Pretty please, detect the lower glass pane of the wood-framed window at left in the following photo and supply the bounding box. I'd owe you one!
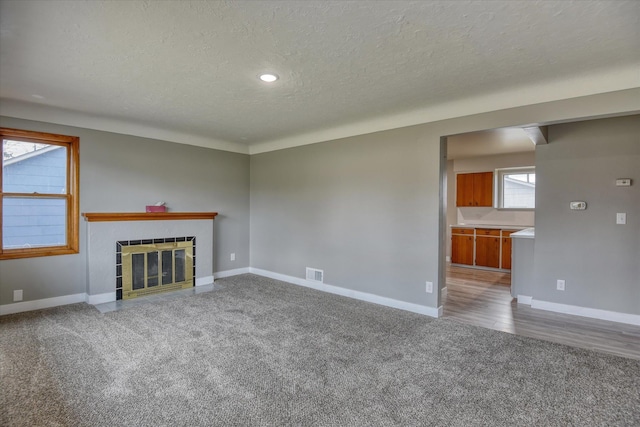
[2,197,67,249]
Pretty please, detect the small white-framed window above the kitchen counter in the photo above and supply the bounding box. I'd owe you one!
[496,166,536,209]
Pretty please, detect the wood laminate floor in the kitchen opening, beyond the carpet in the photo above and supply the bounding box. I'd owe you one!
[443,266,640,359]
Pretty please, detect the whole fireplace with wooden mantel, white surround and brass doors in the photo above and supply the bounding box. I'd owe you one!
[83,212,218,304]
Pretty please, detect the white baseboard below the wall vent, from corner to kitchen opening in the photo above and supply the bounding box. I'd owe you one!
[249,267,443,317]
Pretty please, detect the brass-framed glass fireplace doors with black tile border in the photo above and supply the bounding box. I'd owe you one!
[116,236,196,300]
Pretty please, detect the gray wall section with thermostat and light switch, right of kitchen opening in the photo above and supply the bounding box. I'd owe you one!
[532,116,640,314]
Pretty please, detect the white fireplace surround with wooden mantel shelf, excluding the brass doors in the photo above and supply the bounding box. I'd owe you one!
[83,212,216,304]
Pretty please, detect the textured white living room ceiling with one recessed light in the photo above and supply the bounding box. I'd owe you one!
[0,0,640,153]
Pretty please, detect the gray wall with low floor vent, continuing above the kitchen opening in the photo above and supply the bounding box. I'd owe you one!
[251,90,640,307]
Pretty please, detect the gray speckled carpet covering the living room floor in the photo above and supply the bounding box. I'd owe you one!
[0,275,640,426]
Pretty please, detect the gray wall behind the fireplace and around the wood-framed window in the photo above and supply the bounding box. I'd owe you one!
[0,117,249,305]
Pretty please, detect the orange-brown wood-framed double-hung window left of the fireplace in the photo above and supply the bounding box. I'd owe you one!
[0,128,79,259]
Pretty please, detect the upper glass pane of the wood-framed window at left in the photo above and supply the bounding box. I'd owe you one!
[2,139,67,194]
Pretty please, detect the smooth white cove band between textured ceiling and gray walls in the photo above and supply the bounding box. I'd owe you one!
[0,68,640,155]
